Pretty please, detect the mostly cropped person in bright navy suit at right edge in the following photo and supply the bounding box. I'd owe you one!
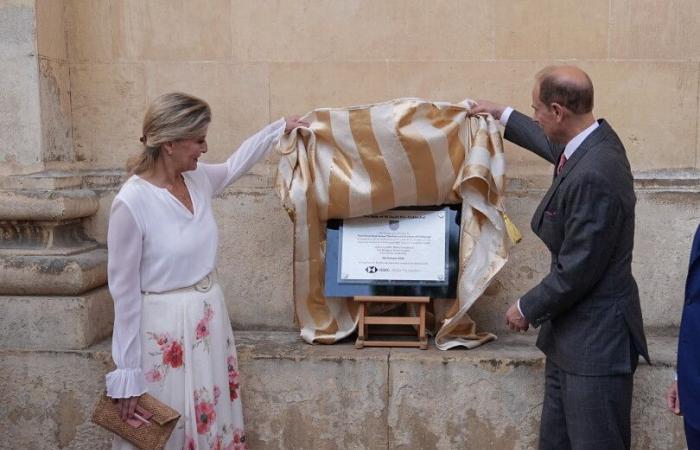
[666,226,700,450]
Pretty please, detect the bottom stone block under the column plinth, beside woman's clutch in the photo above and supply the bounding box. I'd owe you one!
[0,342,112,450]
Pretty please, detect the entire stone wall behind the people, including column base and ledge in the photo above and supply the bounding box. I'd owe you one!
[0,0,700,449]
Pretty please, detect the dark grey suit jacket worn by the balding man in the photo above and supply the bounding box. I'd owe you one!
[505,111,649,376]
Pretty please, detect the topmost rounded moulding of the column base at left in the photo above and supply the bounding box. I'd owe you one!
[0,189,98,220]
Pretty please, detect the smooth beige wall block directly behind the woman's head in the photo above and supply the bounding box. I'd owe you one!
[142,61,274,163]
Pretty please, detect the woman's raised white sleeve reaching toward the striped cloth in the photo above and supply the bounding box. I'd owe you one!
[199,119,285,195]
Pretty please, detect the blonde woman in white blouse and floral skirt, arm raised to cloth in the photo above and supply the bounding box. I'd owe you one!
[106,93,306,449]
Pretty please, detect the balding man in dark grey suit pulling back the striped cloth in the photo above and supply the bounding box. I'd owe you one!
[472,66,649,450]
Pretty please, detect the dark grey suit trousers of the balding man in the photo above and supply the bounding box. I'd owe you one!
[539,358,636,450]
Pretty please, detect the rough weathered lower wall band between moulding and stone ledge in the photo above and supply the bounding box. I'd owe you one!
[68,170,700,334]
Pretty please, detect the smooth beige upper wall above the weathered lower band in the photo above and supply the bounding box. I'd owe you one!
[61,0,700,176]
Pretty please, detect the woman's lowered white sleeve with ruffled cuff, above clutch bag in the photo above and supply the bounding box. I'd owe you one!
[105,198,147,398]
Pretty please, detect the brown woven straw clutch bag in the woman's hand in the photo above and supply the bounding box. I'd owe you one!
[92,394,180,450]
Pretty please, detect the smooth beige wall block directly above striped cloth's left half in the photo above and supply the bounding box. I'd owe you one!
[270,62,391,118]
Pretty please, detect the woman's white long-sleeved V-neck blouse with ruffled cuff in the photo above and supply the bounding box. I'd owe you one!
[105,119,285,398]
